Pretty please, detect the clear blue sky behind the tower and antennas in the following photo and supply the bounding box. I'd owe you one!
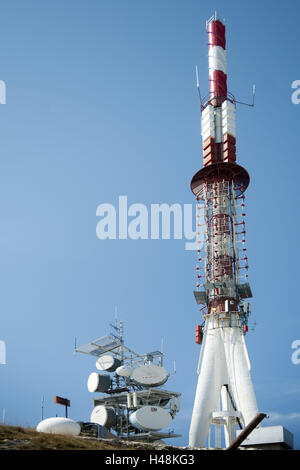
[0,0,300,448]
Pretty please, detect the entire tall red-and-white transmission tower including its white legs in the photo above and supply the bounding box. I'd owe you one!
[189,14,258,447]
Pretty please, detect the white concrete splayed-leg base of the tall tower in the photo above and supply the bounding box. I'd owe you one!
[189,315,258,447]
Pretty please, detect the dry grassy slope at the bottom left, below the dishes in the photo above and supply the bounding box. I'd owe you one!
[0,425,137,450]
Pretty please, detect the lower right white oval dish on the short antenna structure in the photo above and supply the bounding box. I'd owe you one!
[129,406,172,431]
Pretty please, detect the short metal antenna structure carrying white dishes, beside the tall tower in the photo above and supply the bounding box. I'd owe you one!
[75,316,181,441]
